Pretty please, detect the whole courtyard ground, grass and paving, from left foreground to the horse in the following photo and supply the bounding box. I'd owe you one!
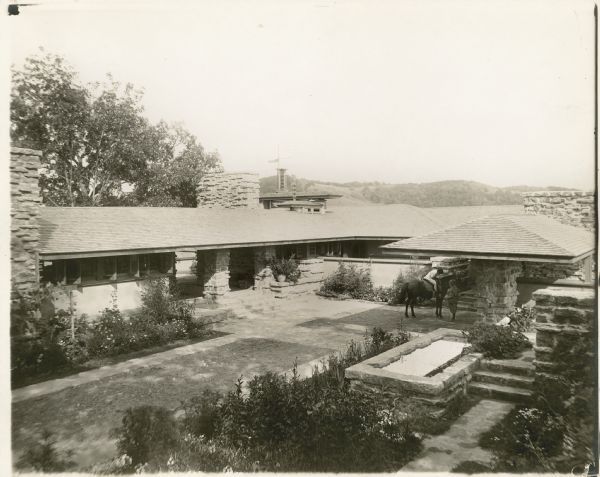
[12,295,474,468]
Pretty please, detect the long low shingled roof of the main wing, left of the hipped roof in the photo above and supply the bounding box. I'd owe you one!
[40,204,524,258]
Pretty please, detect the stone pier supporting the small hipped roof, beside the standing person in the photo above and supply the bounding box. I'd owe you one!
[470,259,521,322]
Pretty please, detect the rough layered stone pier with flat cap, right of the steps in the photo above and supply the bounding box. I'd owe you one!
[533,287,595,386]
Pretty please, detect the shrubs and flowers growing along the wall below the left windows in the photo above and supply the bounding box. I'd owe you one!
[11,277,212,386]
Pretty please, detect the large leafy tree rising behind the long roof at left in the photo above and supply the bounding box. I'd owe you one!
[11,51,220,207]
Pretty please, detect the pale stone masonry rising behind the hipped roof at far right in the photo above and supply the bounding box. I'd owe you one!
[522,191,596,231]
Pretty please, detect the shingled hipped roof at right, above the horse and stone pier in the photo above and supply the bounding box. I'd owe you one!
[382,214,594,261]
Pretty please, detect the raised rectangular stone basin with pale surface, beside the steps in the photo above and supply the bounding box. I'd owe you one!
[345,328,481,407]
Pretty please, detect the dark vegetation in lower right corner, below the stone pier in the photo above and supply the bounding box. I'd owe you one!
[480,334,596,474]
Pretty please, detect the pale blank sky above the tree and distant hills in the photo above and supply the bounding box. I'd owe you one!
[7,0,595,189]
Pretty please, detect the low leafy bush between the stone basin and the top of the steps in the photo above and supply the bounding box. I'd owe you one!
[462,323,533,359]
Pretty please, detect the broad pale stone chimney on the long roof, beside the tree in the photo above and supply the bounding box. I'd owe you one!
[198,172,260,209]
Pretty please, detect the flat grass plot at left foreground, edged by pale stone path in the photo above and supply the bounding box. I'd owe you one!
[12,338,331,468]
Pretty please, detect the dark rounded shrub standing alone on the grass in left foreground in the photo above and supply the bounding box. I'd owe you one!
[114,406,179,466]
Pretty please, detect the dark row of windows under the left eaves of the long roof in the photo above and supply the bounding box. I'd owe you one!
[41,253,175,285]
